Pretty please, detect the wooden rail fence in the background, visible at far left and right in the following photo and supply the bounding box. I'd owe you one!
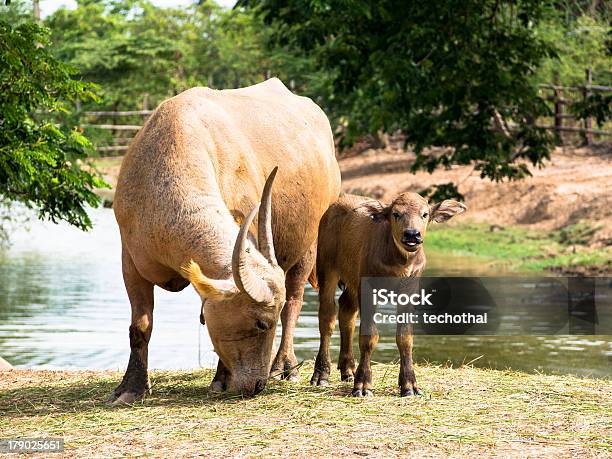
[81,70,612,156]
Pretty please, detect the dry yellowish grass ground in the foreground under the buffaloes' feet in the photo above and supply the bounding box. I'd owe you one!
[0,363,612,458]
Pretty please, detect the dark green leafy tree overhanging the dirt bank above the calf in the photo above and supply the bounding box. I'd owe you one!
[238,0,555,196]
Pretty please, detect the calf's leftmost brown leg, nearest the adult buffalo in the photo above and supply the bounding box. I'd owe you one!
[310,273,338,386]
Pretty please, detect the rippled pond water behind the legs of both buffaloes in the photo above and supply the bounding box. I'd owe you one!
[0,209,612,377]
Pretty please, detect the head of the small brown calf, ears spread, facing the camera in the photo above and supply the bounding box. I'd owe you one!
[359,193,467,252]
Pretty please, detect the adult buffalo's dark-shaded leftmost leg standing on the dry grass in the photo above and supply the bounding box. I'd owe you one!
[110,248,153,404]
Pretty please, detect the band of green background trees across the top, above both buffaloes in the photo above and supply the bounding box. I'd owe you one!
[2,0,612,219]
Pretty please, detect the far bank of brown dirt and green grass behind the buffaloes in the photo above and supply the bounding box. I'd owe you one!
[96,143,612,276]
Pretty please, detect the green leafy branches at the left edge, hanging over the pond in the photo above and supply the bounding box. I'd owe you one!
[0,18,104,229]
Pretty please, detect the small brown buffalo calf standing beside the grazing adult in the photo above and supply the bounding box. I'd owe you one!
[311,193,466,396]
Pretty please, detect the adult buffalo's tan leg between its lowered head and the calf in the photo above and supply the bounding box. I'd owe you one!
[270,245,316,381]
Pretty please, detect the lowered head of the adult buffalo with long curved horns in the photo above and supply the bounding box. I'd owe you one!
[183,169,285,395]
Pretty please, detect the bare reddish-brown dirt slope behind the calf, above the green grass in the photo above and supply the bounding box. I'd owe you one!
[340,144,612,247]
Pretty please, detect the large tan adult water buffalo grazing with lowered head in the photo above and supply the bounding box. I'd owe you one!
[111,79,340,403]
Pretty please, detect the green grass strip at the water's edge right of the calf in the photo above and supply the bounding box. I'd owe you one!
[426,223,612,273]
